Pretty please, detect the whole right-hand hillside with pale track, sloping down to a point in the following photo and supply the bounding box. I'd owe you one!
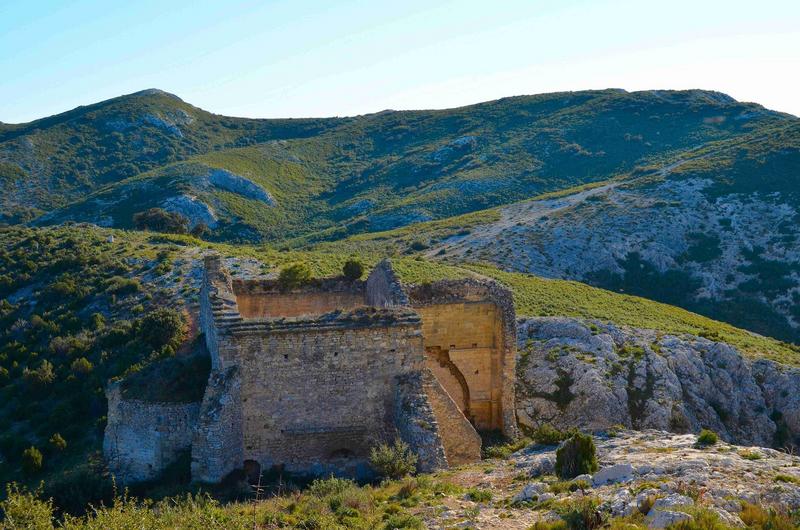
[330,121,800,342]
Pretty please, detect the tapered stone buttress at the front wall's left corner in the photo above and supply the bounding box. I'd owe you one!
[192,366,244,482]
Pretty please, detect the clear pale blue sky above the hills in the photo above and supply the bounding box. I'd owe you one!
[0,0,800,123]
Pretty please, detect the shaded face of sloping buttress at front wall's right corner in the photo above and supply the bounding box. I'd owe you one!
[394,372,450,473]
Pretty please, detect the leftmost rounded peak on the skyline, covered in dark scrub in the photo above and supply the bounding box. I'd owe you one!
[0,89,339,222]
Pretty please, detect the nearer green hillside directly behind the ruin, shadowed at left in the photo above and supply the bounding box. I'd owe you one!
[0,225,800,509]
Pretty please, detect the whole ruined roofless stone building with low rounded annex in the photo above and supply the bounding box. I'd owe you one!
[104,256,516,482]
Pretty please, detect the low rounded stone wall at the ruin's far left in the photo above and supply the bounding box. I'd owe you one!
[103,382,200,483]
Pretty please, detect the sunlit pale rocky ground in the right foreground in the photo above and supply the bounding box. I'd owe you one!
[410,430,800,528]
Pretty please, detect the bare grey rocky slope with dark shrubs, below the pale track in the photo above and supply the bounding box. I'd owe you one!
[427,171,800,339]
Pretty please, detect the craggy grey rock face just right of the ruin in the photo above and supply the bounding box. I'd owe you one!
[517,317,800,447]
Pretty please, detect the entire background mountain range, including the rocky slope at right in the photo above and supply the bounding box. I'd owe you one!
[0,90,800,342]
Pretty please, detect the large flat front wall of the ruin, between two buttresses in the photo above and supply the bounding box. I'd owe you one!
[233,315,423,475]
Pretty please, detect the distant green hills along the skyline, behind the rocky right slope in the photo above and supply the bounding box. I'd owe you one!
[0,90,793,241]
